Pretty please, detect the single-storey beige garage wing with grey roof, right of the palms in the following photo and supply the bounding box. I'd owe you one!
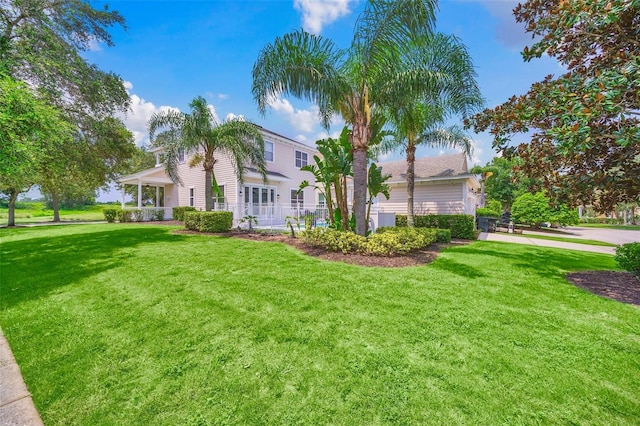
[377,153,480,215]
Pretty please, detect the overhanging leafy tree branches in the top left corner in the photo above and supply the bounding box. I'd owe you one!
[0,0,129,119]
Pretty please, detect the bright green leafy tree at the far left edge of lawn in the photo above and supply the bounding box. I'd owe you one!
[0,77,72,226]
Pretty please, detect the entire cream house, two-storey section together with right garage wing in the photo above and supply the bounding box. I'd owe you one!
[118,127,480,226]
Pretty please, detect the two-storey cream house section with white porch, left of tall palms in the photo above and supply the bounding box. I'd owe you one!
[118,127,323,224]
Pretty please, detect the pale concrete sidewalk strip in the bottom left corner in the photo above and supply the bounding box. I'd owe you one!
[0,330,44,426]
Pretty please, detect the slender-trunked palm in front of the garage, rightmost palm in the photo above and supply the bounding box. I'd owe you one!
[383,33,483,226]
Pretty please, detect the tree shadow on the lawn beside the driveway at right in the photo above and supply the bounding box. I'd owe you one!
[447,243,614,278]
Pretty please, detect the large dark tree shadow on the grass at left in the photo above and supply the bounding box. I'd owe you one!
[0,226,187,309]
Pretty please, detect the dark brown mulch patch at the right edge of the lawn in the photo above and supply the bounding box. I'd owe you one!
[566,271,640,306]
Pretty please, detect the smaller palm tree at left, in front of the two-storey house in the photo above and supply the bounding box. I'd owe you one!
[147,96,267,211]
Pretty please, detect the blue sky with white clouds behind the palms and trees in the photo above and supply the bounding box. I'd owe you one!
[85,0,562,200]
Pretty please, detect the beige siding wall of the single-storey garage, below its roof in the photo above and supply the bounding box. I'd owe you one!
[378,181,467,215]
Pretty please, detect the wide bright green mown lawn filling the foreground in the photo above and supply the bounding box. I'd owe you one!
[0,224,640,425]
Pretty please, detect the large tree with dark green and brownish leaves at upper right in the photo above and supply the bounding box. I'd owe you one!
[470,0,640,212]
